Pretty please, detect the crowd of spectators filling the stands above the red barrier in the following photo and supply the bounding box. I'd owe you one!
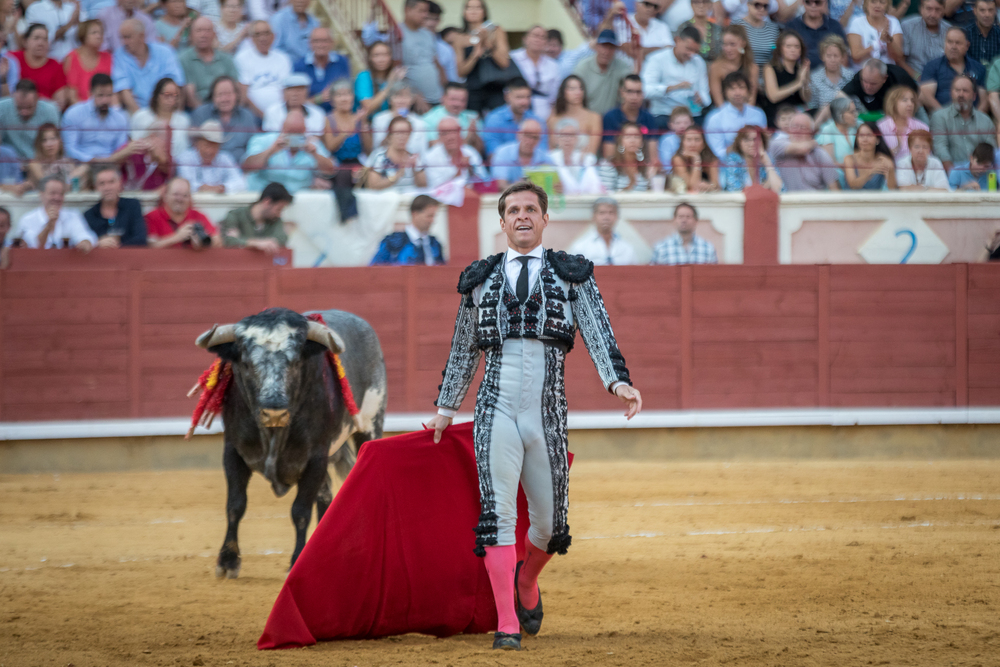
[0,0,1000,261]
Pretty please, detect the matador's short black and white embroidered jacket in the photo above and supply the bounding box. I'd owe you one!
[434,250,632,410]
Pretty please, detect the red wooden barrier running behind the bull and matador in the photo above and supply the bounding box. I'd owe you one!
[0,250,1000,421]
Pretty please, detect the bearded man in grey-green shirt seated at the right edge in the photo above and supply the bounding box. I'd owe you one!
[931,74,997,172]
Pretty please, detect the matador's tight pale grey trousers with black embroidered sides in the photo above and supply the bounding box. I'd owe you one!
[475,339,569,555]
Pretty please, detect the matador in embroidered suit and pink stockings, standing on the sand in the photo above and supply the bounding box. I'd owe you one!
[427,181,642,650]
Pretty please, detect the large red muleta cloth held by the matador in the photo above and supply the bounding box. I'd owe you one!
[257,423,573,649]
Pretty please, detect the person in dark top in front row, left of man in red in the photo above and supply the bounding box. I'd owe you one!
[83,164,146,248]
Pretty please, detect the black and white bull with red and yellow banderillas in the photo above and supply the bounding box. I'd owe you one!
[196,308,386,579]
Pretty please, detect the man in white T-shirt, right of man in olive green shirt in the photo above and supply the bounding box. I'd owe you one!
[233,21,292,118]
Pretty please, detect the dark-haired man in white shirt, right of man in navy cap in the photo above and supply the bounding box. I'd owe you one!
[642,25,712,129]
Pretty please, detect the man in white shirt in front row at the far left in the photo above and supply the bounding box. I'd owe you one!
[18,176,97,254]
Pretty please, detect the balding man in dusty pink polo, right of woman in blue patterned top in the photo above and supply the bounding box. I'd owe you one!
[769,113,840,192]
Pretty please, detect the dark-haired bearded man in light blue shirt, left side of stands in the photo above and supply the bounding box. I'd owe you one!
[62,73,129,163]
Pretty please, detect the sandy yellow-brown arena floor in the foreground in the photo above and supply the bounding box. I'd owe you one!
[0,461,1000,667]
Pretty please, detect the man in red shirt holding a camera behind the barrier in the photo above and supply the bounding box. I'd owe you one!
[146,177,222,250]
